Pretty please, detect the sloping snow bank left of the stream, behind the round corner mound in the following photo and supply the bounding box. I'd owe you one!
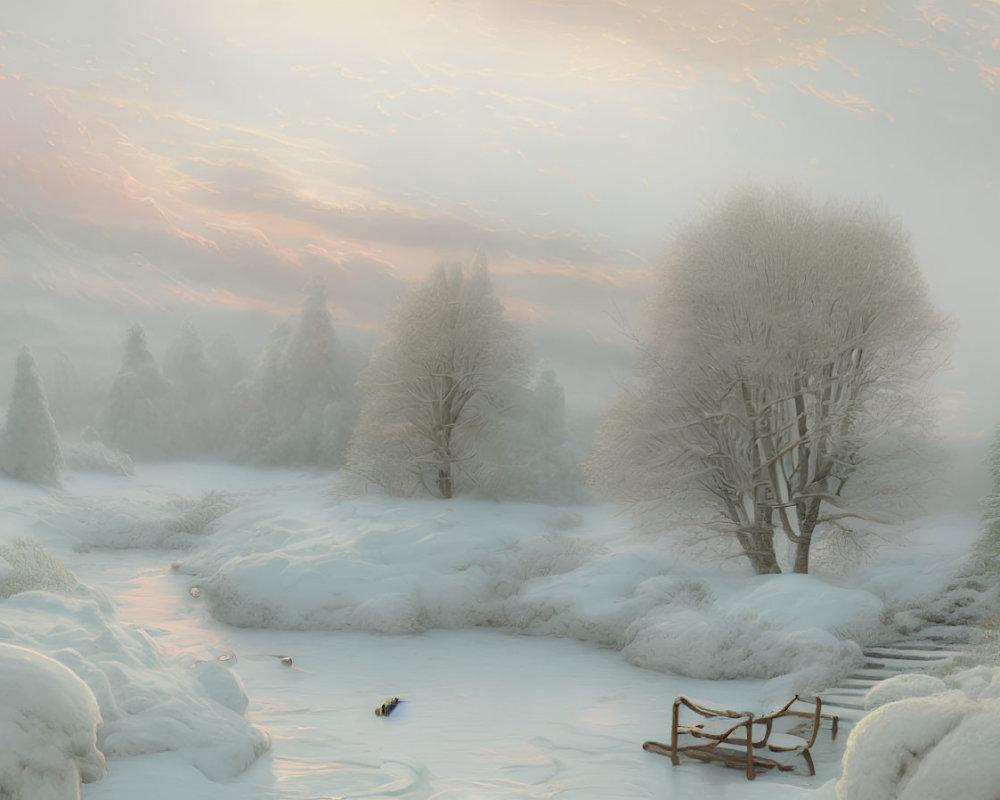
[0,542,268,780]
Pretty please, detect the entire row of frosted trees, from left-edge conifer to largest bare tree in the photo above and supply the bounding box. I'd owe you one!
[0,188,945,573]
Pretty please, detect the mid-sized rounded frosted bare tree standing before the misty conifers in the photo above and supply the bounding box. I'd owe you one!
[348,262,529,498]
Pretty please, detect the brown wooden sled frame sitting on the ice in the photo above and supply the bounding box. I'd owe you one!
[642,695,839,781]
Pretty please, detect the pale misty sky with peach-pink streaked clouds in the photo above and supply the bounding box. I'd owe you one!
[0,0,1000,437]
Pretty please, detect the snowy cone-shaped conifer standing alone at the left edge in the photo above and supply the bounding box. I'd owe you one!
[0,347,62,484]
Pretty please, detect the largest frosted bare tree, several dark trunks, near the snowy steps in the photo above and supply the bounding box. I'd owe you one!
[591,188,942,573]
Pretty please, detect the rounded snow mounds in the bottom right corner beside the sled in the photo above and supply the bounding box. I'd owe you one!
[837,666,1000,800]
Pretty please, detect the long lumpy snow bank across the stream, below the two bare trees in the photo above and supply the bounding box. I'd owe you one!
[181,488,882,692]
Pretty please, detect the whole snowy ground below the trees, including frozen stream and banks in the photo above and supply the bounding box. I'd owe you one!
[0,463,992,800]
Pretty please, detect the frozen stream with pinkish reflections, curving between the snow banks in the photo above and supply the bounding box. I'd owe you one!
[67,550,846,800]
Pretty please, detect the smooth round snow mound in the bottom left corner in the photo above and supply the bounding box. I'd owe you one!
[0,643,107,800]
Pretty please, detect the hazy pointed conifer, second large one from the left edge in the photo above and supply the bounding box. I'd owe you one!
[97,324,178,458]
